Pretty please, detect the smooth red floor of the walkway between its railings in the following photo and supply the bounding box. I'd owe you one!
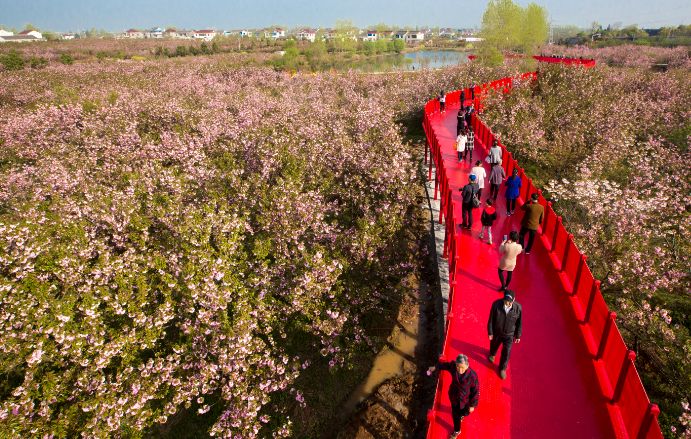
[430,106,615,438]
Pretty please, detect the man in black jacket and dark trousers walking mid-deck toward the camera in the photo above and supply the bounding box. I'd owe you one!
[487,290,523,379]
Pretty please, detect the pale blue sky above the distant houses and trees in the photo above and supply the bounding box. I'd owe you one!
[0,0,691,32]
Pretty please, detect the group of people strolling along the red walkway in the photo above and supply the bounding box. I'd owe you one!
[428,102,544,439]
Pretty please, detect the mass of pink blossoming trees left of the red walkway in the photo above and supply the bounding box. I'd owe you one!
[0,59,474,437]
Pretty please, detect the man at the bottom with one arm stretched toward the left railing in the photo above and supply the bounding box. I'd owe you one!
[427,354,480,439]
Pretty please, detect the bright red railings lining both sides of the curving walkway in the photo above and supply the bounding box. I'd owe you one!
[423,57,662,439]
